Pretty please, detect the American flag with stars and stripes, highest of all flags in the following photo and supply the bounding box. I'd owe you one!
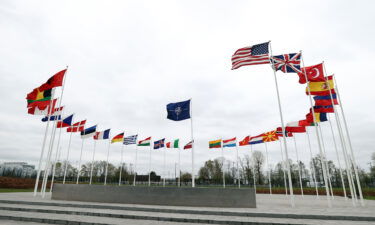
[232,42,270,70]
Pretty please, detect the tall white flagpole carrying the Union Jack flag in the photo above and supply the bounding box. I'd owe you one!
[300,54,332,208]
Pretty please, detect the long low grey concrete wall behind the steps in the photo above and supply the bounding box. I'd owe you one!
[52,184,256,208]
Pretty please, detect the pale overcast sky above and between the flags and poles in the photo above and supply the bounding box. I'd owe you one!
[0,0,375,176]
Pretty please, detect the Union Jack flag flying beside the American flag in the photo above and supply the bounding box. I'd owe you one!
[271,53,301,73]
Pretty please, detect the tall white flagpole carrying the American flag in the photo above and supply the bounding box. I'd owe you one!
[269,41,295,207]
